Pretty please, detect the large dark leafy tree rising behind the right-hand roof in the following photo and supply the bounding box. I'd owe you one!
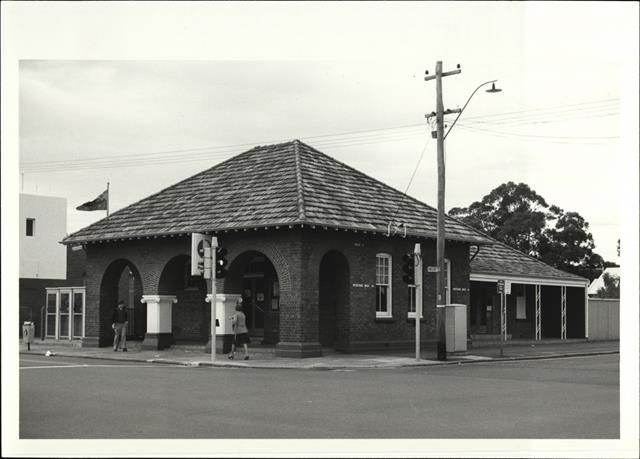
[449,182,606,280]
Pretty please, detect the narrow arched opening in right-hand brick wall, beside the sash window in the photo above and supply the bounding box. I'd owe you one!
[318,250,349,349]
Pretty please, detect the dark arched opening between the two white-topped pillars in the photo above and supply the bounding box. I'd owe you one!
[158,255,211,343]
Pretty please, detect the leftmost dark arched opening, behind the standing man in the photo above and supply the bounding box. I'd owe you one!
[100,259,147,340]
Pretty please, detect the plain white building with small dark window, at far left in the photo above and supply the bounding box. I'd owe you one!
[20,194,67,279]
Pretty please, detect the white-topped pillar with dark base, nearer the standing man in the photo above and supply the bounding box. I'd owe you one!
[140,295,178,349]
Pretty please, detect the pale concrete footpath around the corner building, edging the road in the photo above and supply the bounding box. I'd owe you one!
[20,340,620,370]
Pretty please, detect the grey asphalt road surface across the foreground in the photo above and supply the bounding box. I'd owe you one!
[20,355,620,439]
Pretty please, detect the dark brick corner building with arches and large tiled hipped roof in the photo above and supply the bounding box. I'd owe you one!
[63,140,488,357]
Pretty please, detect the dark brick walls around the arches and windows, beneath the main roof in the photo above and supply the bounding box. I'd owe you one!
[79,228,469,351]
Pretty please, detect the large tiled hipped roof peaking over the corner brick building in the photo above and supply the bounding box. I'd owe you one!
[63,140,487,244]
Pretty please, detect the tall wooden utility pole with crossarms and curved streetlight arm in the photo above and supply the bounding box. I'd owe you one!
[424,61,501,360]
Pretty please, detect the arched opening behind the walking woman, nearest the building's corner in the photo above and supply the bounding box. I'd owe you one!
[224,250,280,344]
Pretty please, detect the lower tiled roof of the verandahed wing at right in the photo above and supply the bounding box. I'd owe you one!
[471,236,587,282]
